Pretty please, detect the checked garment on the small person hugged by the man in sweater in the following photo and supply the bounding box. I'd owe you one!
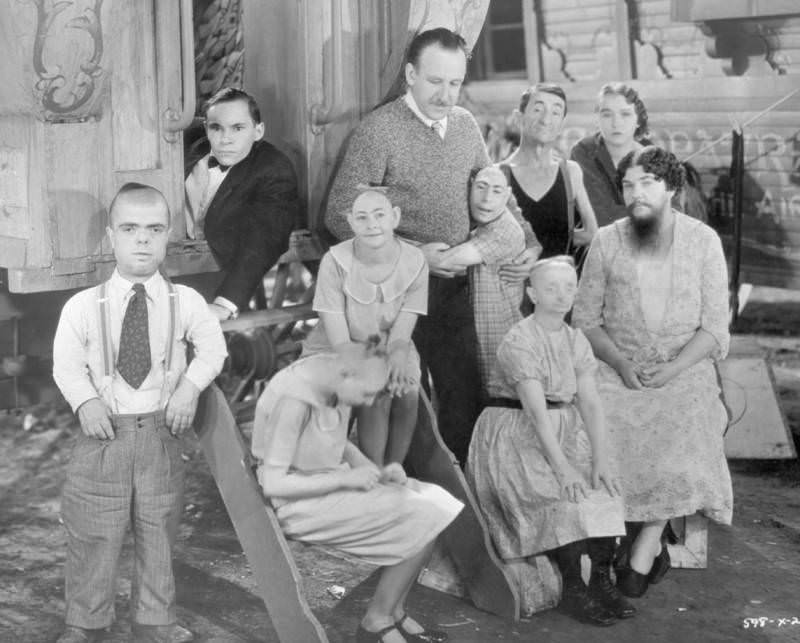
[469,210,525,391]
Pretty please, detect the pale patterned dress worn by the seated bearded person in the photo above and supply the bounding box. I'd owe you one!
[572,212,733,524]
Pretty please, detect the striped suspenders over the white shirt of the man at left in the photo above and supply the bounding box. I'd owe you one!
[97,280,180,412]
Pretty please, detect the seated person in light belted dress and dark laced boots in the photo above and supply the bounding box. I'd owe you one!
[467,255,635,625]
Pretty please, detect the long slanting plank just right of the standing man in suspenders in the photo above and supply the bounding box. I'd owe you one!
[195,384,328,643]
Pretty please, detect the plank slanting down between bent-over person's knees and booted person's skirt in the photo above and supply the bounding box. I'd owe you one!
[406,392,520,620]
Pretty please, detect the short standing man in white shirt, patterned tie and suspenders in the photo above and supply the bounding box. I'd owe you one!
[53,183,227,643]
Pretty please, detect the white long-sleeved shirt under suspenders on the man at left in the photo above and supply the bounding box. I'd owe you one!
[53,270,227,413]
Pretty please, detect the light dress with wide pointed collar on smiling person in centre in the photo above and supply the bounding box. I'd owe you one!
[303,239,428,383]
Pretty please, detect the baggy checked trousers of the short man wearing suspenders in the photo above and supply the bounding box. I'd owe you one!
[61,412,184,629]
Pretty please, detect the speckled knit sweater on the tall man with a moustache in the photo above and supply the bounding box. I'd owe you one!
[325,96,489,246]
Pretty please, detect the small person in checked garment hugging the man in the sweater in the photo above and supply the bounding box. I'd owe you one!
[432,166,541,395]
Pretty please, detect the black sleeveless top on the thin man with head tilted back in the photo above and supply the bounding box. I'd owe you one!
[508,168,578,259]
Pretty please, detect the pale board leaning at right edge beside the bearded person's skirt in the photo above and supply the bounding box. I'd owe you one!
[719,355,797,459]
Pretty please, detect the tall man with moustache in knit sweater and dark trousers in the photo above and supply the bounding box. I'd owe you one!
[325,28,535,462]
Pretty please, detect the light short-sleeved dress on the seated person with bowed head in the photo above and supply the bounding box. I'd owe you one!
[252,354,463,565]
